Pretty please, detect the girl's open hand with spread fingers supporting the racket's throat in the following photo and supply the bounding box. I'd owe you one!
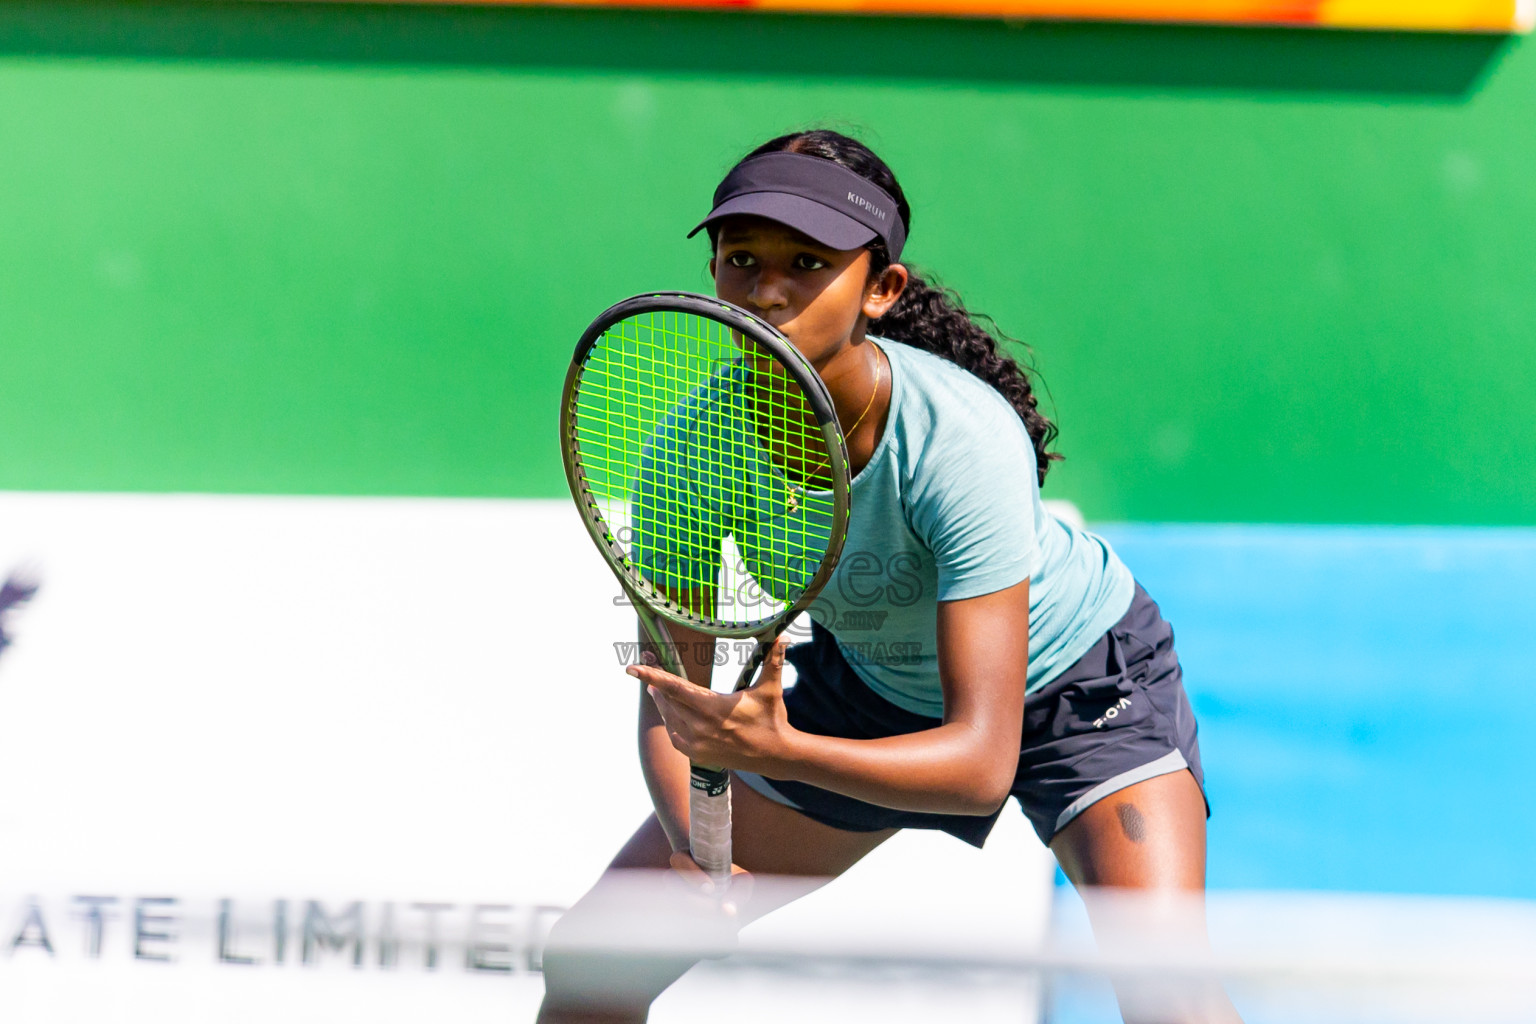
[627,637,796,777]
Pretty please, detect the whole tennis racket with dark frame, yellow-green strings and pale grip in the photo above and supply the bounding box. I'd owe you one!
[561,292,848,880]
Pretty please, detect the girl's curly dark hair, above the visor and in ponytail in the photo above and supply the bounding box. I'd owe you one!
[742,129,1061,484]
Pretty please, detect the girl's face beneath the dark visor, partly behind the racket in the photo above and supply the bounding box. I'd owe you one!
[710,216,906,368]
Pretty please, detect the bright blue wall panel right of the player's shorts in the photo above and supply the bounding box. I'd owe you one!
[1101,525,1536,898]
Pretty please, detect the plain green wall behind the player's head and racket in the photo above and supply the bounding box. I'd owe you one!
[0,2,1536,524]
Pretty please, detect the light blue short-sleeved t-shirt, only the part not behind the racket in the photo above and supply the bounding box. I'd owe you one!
[811,339,1135,717]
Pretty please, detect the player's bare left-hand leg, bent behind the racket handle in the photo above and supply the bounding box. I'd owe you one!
[539,781,895,1024]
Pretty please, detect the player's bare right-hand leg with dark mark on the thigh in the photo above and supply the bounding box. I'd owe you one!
[1051,771,1241,1024]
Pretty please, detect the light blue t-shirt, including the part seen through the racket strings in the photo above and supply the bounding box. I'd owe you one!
[634,339,1135,717]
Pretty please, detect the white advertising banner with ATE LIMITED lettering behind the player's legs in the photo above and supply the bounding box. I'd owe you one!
[0,493,1052,1022]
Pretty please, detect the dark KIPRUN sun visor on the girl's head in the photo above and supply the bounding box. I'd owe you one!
[688,154,906,263]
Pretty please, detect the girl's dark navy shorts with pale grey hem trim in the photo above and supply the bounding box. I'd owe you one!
[737,585,1209,846]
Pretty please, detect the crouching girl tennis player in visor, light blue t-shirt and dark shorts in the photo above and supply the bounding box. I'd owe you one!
[541,130,1236,1024]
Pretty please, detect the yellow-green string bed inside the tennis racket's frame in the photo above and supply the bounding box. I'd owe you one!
[574,310,834,628]
